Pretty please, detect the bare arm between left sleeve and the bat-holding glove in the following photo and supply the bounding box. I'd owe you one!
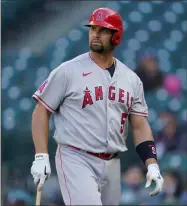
[32,104,50,153]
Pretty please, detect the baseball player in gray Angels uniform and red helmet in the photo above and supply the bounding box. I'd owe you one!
[31,8,163,205]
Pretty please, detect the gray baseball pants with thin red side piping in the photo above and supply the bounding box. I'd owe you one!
[55,145,121,205]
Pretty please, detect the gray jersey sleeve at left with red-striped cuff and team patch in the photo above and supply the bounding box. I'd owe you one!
[32,66,68,113]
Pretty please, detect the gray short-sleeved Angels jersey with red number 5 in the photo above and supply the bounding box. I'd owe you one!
[33,53,148,153]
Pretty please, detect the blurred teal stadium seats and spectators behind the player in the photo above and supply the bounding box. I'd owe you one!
[1,0,187,205]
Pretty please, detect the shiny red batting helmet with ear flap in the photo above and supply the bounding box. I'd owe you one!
[85,8,123,46]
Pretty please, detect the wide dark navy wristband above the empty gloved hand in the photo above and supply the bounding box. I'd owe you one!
[136,140,157,164]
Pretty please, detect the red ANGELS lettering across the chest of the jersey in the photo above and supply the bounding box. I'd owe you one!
[82,86,133,111]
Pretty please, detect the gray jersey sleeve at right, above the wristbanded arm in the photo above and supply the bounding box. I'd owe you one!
[130,78,148,116]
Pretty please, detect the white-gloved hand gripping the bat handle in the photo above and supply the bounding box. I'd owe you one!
[31,153,51,190]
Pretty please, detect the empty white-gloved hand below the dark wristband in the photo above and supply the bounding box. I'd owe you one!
[145,164,164,196]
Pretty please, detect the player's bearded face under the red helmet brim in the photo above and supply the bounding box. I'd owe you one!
[89,26,114,53]
